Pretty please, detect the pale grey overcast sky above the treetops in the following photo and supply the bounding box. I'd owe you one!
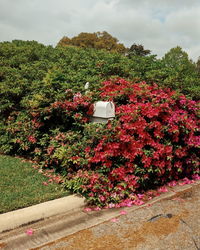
[0,0,200,61]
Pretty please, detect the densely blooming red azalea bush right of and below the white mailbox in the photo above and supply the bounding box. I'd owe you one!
[65,79,200,207]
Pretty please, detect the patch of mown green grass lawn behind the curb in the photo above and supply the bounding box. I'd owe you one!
[0,155,69,213]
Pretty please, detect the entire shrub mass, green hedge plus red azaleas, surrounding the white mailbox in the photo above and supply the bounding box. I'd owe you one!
[0,39,200,206]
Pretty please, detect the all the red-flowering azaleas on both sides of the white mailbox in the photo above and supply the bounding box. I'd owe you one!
[1,74,200,207]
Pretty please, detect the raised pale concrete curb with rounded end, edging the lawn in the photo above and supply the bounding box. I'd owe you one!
[0,195,84,233]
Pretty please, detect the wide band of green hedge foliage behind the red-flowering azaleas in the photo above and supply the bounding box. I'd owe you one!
[0,40,200,128]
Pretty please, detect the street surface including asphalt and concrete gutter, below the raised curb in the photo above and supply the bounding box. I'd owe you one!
[0,181,200,250]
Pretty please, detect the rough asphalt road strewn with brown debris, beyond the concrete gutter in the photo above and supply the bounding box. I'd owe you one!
[35,185,200,250]
